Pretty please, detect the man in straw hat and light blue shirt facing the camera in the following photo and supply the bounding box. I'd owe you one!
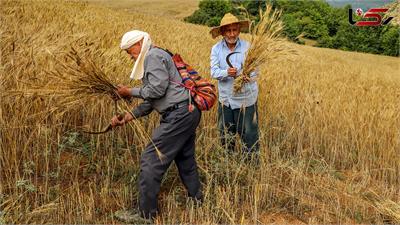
[210,13,259,156]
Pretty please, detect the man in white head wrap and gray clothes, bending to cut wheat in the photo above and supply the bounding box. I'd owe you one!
[111,30,203,223]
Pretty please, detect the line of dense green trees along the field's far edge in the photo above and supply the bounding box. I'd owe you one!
[185,0,400,56]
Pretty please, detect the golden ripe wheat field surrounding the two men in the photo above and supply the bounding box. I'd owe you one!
[0,0,400,224]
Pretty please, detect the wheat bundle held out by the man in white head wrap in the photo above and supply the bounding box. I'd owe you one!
[1,46,120,118]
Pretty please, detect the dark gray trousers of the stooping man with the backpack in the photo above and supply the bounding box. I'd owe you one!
[139,106,202,218]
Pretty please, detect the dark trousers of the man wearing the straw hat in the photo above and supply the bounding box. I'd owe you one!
[218,103,259,153]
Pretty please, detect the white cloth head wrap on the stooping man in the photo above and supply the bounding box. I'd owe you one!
[121,30,151,80]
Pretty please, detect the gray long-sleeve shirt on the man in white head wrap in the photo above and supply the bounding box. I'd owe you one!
[132,46,189,118]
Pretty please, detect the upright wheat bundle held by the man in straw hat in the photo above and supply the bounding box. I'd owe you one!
[234,5,295,93]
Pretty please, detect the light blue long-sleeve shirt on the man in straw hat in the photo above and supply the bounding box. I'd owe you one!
[211,39,258,109]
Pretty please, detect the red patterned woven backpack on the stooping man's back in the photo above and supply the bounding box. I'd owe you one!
[160,50,217,111]
